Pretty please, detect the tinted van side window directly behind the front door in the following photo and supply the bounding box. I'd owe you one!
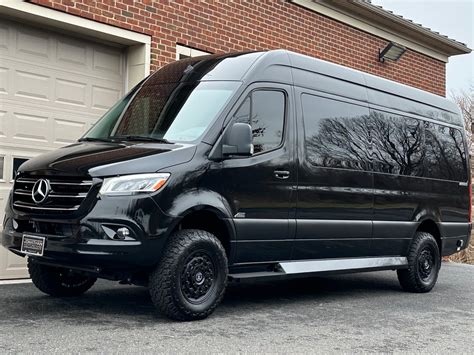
[301,94,370,170]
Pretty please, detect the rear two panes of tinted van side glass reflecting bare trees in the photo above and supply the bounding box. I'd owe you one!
[370,111,467,181]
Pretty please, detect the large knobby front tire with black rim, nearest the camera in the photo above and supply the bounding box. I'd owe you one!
[149,229,228,321]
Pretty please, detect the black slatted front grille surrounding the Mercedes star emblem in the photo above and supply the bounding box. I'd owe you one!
[13,177,92,214]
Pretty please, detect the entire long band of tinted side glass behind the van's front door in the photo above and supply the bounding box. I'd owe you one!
[302,94,467,181]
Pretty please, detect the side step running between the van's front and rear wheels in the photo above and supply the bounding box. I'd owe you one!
[229,256,408,279]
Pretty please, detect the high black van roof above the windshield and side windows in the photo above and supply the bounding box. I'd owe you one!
[152,49,463,126]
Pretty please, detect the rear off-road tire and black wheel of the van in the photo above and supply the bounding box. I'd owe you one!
[397,232,441,293]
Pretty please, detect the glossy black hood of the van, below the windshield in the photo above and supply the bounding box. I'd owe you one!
[19,142,196,177]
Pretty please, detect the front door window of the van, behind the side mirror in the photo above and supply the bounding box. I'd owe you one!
[235,90,285,153]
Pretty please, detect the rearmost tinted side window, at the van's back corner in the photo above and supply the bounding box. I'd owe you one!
[425,122,467,181]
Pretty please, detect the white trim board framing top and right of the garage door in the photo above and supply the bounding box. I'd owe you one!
[0,0,151,91]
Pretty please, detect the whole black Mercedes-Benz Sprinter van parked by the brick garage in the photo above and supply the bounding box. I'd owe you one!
[2,50,471,320]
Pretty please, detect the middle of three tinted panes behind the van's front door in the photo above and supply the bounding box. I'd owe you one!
[370,111,425,176]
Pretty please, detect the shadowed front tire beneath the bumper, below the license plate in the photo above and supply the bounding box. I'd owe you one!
[28,258,97,297]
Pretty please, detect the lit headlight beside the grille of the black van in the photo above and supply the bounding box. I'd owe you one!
[100,173,170,195]
